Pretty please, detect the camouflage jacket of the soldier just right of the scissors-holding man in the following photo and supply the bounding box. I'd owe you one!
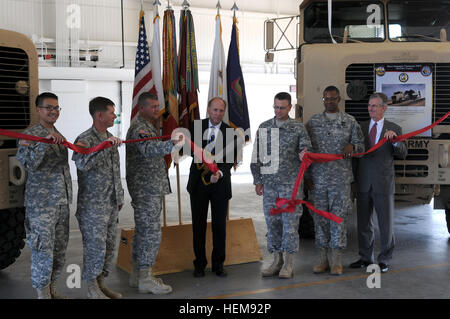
[250,117,311,185]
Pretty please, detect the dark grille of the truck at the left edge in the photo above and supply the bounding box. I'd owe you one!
[0,46,30,130]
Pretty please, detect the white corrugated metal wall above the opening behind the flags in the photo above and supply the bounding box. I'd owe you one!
[0,0,295,73]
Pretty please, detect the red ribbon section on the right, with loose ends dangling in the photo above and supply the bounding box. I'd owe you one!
[270,112,450,224]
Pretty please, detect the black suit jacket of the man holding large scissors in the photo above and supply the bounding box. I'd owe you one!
[187,119,237,200]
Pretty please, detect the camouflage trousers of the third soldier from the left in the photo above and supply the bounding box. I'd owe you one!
[131,195,162,269]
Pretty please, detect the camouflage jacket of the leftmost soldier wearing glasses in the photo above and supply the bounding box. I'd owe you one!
[17,123,72,207]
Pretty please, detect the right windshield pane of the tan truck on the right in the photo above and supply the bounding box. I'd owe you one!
[387,0,450,42]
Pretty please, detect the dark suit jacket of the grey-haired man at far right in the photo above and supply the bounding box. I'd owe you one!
[355,119,408,194]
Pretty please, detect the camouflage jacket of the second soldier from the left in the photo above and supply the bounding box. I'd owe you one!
[72,126,124,209]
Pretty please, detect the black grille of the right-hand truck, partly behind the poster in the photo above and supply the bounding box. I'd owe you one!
[345,63,450,125]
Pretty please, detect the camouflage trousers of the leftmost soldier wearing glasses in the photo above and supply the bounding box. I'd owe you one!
[25,205,70,289]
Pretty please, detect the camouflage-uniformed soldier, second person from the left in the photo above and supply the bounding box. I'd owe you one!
[72,97,124,299]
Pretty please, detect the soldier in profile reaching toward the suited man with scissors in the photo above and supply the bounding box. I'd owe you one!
[126,92,184,294]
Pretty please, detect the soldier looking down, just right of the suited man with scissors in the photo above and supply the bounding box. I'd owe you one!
[250,92,311,278]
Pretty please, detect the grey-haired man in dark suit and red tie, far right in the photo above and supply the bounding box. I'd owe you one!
[350,93,408,273]
